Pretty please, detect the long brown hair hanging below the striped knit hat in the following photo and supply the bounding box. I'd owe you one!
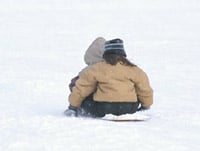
[103,54,136,67]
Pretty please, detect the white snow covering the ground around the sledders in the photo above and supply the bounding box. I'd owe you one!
[0,0,200,151]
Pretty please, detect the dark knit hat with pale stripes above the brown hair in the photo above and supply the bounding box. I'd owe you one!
[103,38,126,57]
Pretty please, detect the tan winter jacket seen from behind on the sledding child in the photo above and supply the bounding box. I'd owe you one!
[69,62,153,107]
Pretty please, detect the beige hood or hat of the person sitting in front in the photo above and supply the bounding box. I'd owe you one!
[84,37,106,65]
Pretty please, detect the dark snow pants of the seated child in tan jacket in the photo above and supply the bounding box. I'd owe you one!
[81,94,139,117]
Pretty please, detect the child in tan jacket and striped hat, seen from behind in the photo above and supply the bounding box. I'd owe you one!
[65,39,153,117]
